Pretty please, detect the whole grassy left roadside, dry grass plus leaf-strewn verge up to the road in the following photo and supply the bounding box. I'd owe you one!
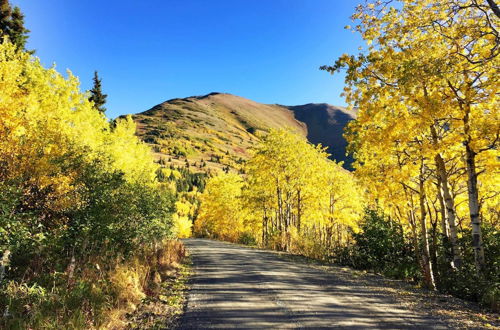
[0,240,191,329]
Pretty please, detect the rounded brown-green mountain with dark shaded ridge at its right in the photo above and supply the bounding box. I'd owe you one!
[132,93,355,172]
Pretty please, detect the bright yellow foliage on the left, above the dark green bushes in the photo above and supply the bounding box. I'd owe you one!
[0,43,156,215]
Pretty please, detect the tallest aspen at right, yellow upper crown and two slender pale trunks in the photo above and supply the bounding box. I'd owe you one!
[324,0,500,274]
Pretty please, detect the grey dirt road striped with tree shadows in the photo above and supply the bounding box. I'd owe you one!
[180,239,448,329]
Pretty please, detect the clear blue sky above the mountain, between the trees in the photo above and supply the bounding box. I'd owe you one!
[11,0,361,118]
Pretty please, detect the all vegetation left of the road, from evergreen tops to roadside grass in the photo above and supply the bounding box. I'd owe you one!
[0,1,191,329]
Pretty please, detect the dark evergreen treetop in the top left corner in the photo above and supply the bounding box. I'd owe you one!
[0,0,34,53]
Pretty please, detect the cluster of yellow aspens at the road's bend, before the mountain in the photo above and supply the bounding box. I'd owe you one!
[195,130,364,255]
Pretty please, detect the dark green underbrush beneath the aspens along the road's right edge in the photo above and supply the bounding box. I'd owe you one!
[331,210,500,311]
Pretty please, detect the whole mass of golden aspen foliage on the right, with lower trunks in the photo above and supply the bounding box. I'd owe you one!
[325,0,500,287]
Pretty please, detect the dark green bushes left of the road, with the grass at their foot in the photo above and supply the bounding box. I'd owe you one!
[0,156,174,329]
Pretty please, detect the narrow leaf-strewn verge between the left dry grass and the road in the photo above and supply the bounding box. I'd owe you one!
[127,255,192,329]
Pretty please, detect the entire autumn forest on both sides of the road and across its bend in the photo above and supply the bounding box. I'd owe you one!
[0,0,500,329]
